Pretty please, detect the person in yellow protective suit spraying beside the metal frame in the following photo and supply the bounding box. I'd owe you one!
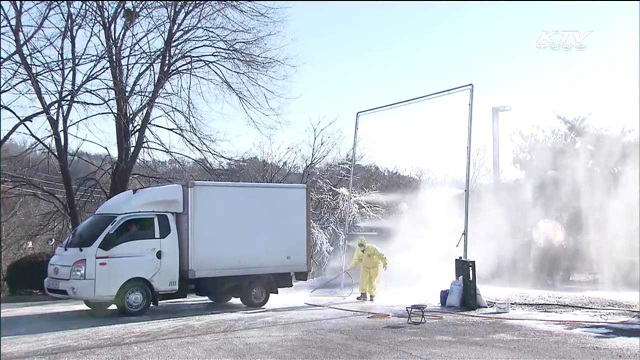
[349,237,387,301]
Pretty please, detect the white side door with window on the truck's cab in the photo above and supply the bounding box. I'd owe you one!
[95,215,161,299]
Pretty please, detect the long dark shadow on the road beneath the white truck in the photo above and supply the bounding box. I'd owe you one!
[0,300,315,338]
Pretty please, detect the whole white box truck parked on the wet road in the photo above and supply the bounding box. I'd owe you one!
[45,181,311,315]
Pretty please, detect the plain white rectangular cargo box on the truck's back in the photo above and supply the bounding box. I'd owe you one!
[177,181,311,279]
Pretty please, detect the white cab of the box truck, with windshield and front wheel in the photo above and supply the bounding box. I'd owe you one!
[45,185,183,314]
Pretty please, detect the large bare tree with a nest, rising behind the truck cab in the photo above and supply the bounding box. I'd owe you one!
[91,1,287,196]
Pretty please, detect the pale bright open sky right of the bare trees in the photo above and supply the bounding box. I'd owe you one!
[2,2,640,177]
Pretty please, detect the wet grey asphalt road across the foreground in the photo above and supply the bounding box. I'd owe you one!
[0,293,640,360]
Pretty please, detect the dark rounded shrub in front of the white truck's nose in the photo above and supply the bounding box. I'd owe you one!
[5,252,51,295]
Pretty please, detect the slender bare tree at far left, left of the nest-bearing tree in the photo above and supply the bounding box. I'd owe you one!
[1,1,106,227]
